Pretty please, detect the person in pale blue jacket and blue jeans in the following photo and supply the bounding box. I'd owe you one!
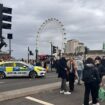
[76,58,84,85]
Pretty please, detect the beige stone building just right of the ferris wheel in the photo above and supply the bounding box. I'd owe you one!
[65,39,85,54]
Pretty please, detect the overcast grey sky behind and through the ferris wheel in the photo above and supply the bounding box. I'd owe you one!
[0,0,105,58]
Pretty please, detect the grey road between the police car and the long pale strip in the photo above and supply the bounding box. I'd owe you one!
[0,72,59,92]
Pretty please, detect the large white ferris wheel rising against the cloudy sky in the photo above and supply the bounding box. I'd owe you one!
[35,18,66,59]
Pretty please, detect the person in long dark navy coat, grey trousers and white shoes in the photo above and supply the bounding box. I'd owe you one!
[58,56,71,95]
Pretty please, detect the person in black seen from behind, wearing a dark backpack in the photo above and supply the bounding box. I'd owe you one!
[82,58,100,105]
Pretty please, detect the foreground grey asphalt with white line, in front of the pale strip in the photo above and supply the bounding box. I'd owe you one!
[0,85,105,105]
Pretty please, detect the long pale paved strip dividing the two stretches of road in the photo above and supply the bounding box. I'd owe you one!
[0,74,104,105]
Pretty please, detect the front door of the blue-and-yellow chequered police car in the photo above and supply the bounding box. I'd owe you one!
[14,62,30,76]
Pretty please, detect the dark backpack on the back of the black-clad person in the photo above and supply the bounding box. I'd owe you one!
[82,68,96,83]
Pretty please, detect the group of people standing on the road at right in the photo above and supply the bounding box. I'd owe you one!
[55,55,105,105]
